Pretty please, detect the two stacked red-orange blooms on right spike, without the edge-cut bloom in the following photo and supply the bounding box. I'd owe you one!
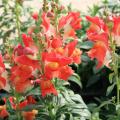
[86,16,110,69]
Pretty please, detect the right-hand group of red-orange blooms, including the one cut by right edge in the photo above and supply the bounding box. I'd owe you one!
[86,16,120,68]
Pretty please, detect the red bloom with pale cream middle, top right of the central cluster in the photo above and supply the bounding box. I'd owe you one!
[58,12,81,40]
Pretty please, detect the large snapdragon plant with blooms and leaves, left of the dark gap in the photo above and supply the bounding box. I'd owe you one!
[0,0,89,120]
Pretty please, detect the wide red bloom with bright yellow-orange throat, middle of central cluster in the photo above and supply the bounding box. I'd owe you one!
[44,52,72,79]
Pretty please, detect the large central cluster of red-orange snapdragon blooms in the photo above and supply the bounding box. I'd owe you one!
[10,12,82,97]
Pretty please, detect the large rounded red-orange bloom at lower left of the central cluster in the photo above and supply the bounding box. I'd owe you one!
[10,65,33,93]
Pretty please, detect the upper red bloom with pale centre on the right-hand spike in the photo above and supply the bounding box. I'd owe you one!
[86,16,109,47]
